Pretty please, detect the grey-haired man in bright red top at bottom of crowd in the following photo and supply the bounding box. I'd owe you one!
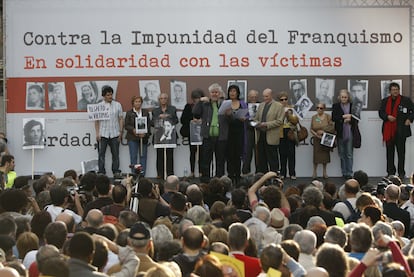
[228,223,262,277]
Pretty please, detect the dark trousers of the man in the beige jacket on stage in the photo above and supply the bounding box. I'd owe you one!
[256,134,279,173]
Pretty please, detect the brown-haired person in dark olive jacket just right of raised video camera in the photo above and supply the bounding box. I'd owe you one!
[138,178,170,226]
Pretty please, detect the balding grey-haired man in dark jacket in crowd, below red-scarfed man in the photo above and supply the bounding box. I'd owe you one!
[382,184,410,237]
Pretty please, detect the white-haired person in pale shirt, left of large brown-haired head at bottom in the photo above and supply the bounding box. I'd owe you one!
[293,230,317,270]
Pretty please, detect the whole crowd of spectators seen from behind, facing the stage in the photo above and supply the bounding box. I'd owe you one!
[0,163,414,277]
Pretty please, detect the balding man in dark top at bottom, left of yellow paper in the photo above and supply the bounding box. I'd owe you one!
[172,227,206,277]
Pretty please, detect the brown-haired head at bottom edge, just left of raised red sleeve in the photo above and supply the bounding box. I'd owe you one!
[316,243,348,277]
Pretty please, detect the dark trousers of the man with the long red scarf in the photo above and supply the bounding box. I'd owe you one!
[387,135,406,177]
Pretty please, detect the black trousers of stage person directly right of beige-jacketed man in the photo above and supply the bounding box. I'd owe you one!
[279,132,296,177]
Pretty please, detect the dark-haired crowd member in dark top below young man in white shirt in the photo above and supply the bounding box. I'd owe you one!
[84,174,114,217]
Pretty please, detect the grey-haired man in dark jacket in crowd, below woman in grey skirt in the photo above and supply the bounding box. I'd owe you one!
[289,186,336,228]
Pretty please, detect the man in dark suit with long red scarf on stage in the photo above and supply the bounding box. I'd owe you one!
[378,82,414,178]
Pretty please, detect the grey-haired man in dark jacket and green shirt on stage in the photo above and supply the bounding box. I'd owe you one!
[193,83,229,182]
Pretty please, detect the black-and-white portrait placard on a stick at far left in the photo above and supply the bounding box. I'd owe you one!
[23,118,45,149]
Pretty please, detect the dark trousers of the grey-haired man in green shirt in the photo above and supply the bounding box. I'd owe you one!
[201,137,227,178]
